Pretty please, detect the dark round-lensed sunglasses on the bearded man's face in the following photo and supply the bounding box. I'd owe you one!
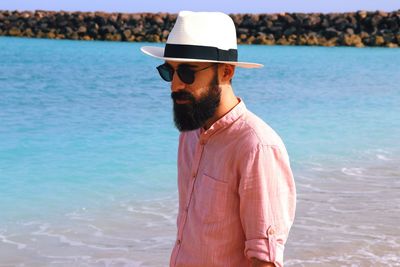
[157,63,216,84]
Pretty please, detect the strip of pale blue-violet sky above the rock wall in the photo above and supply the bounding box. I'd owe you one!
[0,0,400,13]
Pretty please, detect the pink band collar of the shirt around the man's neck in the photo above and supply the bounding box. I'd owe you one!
[199,98,247,143]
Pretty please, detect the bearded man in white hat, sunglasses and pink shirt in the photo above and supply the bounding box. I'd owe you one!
[142,11,296,267]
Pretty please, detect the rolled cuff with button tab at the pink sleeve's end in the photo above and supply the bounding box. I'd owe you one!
[244,237,284,267]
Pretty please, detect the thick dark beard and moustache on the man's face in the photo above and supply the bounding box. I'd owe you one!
[171,73,221,132]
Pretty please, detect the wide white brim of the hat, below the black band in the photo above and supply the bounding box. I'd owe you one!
[140,46,264,69]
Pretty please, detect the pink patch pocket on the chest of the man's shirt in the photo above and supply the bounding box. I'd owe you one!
[194,174,229,223]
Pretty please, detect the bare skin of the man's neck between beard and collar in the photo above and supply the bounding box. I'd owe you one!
[203,85,239,130]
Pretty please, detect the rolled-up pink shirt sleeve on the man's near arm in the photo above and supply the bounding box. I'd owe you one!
[239,145,296,267]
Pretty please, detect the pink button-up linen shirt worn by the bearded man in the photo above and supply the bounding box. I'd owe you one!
[170,99,296,267]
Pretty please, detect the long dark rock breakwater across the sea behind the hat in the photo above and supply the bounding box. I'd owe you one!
[0,10,400,47]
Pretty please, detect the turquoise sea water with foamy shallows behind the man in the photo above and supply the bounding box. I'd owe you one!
[0,37,400,266]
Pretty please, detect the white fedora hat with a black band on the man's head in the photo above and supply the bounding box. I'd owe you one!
[141,11,263,68]
